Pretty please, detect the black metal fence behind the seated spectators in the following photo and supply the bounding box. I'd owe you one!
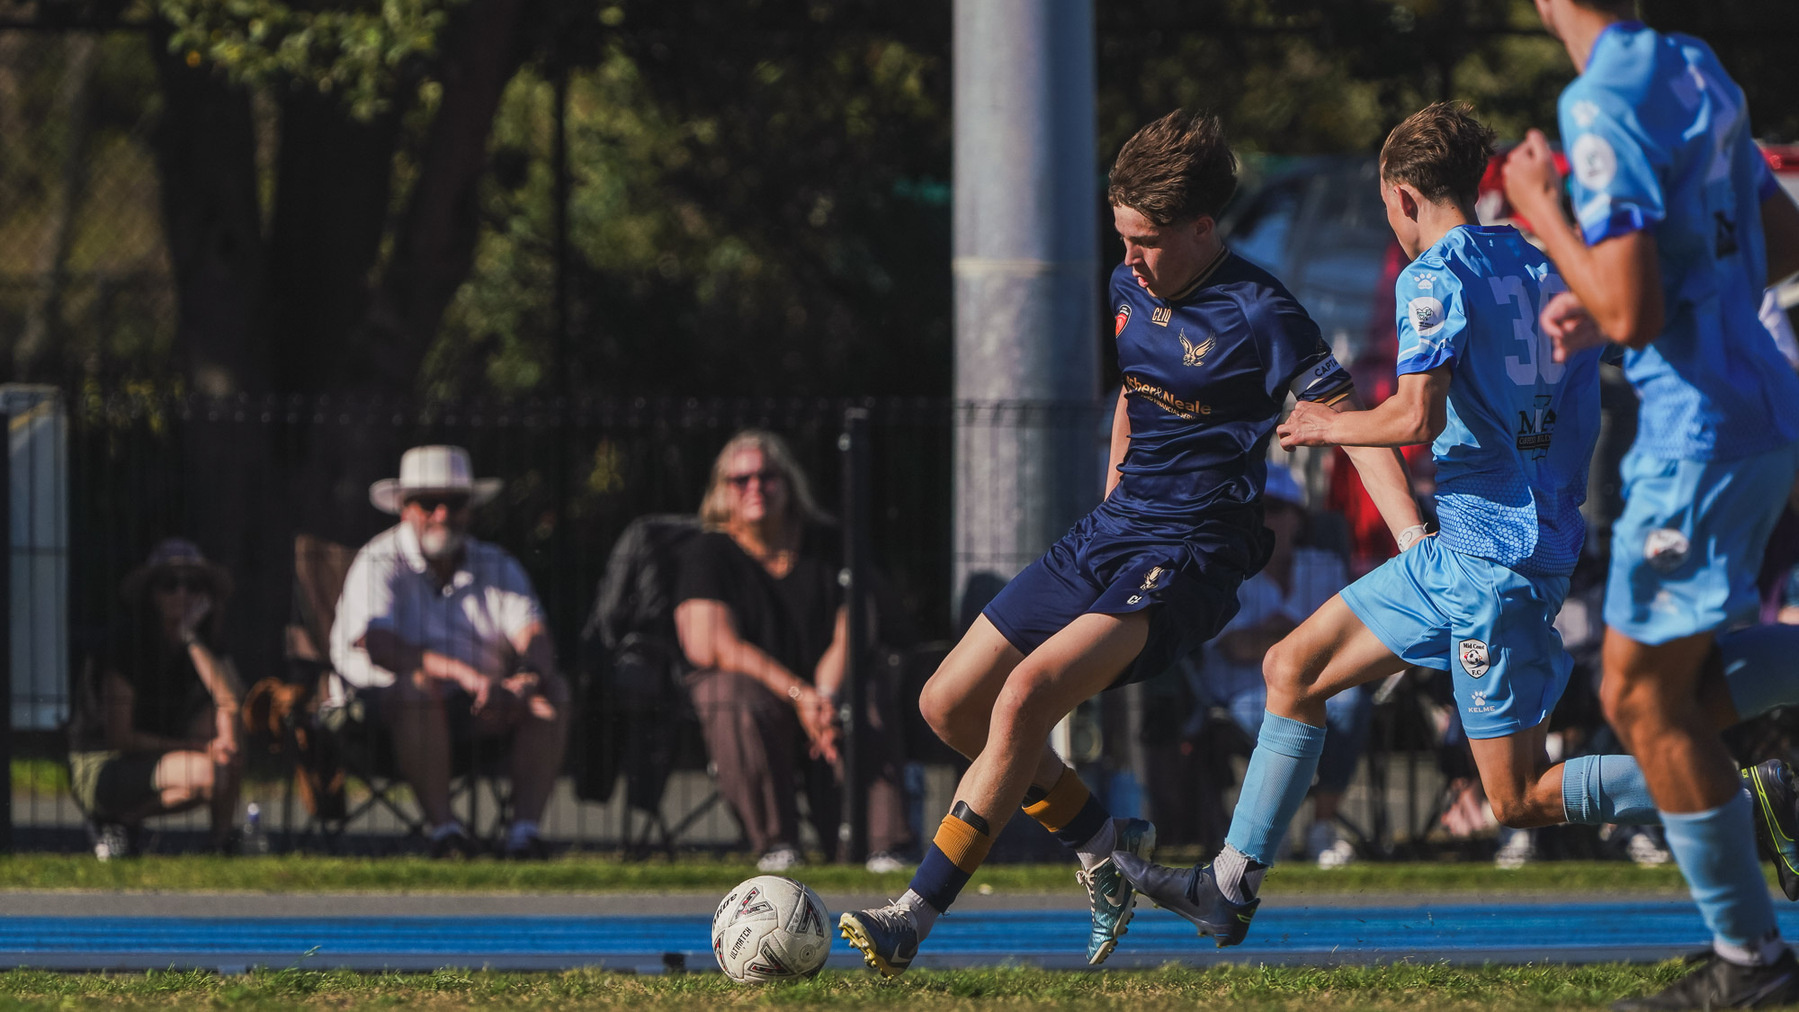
[0,386,1719,869]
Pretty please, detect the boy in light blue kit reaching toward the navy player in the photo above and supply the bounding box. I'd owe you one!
[1114,102,1791,945]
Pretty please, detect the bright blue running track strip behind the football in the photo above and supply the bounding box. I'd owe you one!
[0,901,1799,972]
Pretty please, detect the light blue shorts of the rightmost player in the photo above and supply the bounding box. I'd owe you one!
[1605,444,1799,645]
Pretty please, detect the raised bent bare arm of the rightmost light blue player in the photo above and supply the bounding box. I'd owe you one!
[1506,129,1664,349]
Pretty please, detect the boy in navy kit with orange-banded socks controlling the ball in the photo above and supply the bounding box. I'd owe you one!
[840,111,1423,976]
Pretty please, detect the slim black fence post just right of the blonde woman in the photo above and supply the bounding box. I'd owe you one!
[837,408,873,863]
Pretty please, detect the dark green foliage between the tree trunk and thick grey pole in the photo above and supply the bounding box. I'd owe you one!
[426,0,950,395]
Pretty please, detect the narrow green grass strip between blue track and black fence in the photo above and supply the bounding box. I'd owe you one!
[0,854,1712,899]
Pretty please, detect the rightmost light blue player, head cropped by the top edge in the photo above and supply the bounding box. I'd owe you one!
[1506,0,1799,1008]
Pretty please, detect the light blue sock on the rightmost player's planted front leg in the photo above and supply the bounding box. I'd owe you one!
[1662,791,1776,953]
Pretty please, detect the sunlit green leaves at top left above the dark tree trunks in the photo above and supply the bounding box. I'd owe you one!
[153,0,468,119]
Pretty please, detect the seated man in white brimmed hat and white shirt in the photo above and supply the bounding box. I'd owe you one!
[331,446,568,859]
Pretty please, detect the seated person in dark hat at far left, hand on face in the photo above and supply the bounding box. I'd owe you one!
[68,537,243,859]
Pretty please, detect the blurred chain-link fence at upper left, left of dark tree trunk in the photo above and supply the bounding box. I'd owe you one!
[0,24,176,381]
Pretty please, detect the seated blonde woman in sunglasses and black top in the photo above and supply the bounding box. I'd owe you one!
[675,430,910,872]
